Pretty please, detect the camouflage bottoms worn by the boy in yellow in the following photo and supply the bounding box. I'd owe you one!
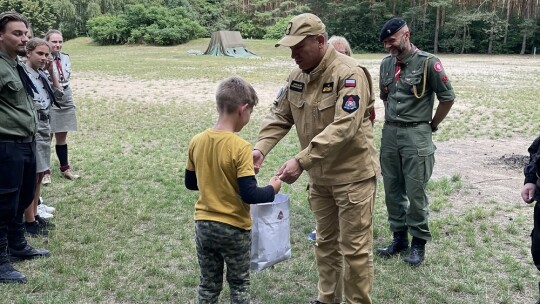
[195,221,251,304]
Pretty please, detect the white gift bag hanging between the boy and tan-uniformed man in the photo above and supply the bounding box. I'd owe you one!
[250,193,291,271]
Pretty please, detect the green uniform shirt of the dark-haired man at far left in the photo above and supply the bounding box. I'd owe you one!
[0,51,37,137]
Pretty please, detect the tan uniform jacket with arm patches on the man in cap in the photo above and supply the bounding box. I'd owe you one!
[254,45,379,185]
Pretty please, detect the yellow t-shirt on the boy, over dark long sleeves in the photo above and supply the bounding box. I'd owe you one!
[187,129,255,230]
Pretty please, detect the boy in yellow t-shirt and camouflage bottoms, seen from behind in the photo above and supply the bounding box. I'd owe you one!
[185,77,281,304]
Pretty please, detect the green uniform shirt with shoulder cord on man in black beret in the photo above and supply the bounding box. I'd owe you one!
[379,45,456,123]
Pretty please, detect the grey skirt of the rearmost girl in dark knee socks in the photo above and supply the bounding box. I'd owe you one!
[50,87,77,133]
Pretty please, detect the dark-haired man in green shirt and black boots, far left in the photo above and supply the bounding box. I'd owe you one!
[0,12,49,283]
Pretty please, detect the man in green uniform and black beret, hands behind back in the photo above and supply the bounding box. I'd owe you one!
[377,17,455,266]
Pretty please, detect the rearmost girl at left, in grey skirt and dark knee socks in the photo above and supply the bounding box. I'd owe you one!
[44,30,79,183]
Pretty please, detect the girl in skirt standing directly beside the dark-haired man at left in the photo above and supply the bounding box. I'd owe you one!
[24,38,62,236]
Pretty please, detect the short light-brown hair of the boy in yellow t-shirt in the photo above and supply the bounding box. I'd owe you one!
[216,76,259,114]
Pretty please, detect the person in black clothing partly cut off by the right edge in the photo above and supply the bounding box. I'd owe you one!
[521,136,540,304]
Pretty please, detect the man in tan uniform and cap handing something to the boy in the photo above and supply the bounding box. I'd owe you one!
[253,14,379,303]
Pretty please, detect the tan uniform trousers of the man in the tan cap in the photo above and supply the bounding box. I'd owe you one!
[309,177,377,304]
